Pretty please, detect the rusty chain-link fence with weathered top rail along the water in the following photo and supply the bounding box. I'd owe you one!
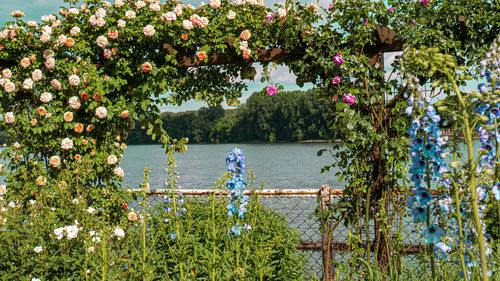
[145,185,423,279]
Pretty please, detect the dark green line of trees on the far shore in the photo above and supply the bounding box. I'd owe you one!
[128,90,334,144]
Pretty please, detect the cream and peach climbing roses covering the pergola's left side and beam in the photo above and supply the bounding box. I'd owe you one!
[0,0,401,201]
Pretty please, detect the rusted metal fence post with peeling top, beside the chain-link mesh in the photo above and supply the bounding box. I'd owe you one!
[320,185,335,281]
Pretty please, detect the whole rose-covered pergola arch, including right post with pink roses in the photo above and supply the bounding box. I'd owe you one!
[0,0,494,276]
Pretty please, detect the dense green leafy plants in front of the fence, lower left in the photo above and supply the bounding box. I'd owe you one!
[0,163,304,280]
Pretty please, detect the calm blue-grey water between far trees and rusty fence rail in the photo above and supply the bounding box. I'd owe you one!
[120,143,341,189]
